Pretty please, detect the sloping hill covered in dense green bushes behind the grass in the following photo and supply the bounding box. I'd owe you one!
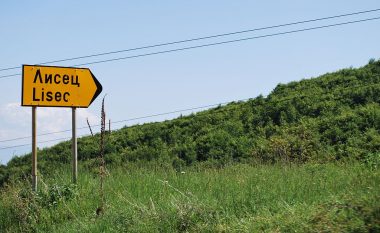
[0,60,380,185]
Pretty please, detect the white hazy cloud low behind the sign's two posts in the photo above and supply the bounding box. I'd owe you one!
[0,103,100,164]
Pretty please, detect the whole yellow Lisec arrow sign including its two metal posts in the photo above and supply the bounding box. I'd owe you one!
[21,65,102,191]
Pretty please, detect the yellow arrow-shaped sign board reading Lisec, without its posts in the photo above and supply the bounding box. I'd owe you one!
[21,65,102,108]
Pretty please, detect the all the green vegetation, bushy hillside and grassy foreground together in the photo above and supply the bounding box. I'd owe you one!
[0,60,380,232]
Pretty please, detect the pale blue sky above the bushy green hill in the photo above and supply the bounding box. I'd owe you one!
[0,0,380,163]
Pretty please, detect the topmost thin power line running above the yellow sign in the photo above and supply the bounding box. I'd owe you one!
[0,8,380,73]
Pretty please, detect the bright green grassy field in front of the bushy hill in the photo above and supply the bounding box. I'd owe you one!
[0,164,380,232]
